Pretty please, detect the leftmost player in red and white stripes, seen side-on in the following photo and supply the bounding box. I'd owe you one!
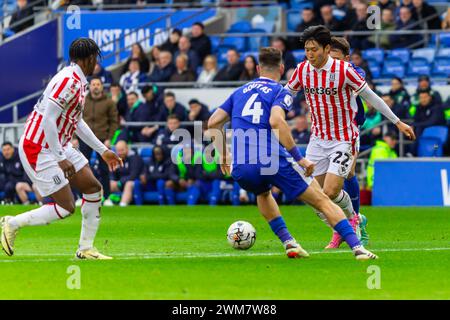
[1,38,122,259]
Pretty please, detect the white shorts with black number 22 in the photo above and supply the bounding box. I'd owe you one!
[306,136,353,178]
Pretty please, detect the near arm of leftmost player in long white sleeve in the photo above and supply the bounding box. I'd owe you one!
[42,100,75,179]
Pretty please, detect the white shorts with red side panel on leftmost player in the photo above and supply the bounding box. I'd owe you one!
[19,137,88,197]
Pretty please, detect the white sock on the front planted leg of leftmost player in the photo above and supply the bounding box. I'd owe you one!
[79,191,102,250]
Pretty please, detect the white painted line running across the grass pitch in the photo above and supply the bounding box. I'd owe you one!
[0,247,450,263]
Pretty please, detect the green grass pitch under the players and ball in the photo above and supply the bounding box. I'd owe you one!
[0,206,450,299]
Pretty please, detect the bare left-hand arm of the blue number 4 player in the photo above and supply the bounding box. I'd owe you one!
[208,108,231,175]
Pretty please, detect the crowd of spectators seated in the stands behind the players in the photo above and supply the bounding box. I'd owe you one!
[0,0,450,206]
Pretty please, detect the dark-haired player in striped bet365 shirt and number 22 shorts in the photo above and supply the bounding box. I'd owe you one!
[286,25,415,244]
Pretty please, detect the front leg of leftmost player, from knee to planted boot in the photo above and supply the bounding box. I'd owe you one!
[70,164,111,259]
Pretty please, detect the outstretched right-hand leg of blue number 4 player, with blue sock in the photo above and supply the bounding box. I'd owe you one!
[299,180,378,260]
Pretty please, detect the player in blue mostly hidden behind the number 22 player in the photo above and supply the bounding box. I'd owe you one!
[326,37,369,249]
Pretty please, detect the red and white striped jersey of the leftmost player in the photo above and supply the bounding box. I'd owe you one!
[24,63,87,148]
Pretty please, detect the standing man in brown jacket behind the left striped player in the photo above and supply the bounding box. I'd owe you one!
[79,77,119,206]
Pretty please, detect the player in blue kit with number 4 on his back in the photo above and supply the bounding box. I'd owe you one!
[208,48,377,260]
